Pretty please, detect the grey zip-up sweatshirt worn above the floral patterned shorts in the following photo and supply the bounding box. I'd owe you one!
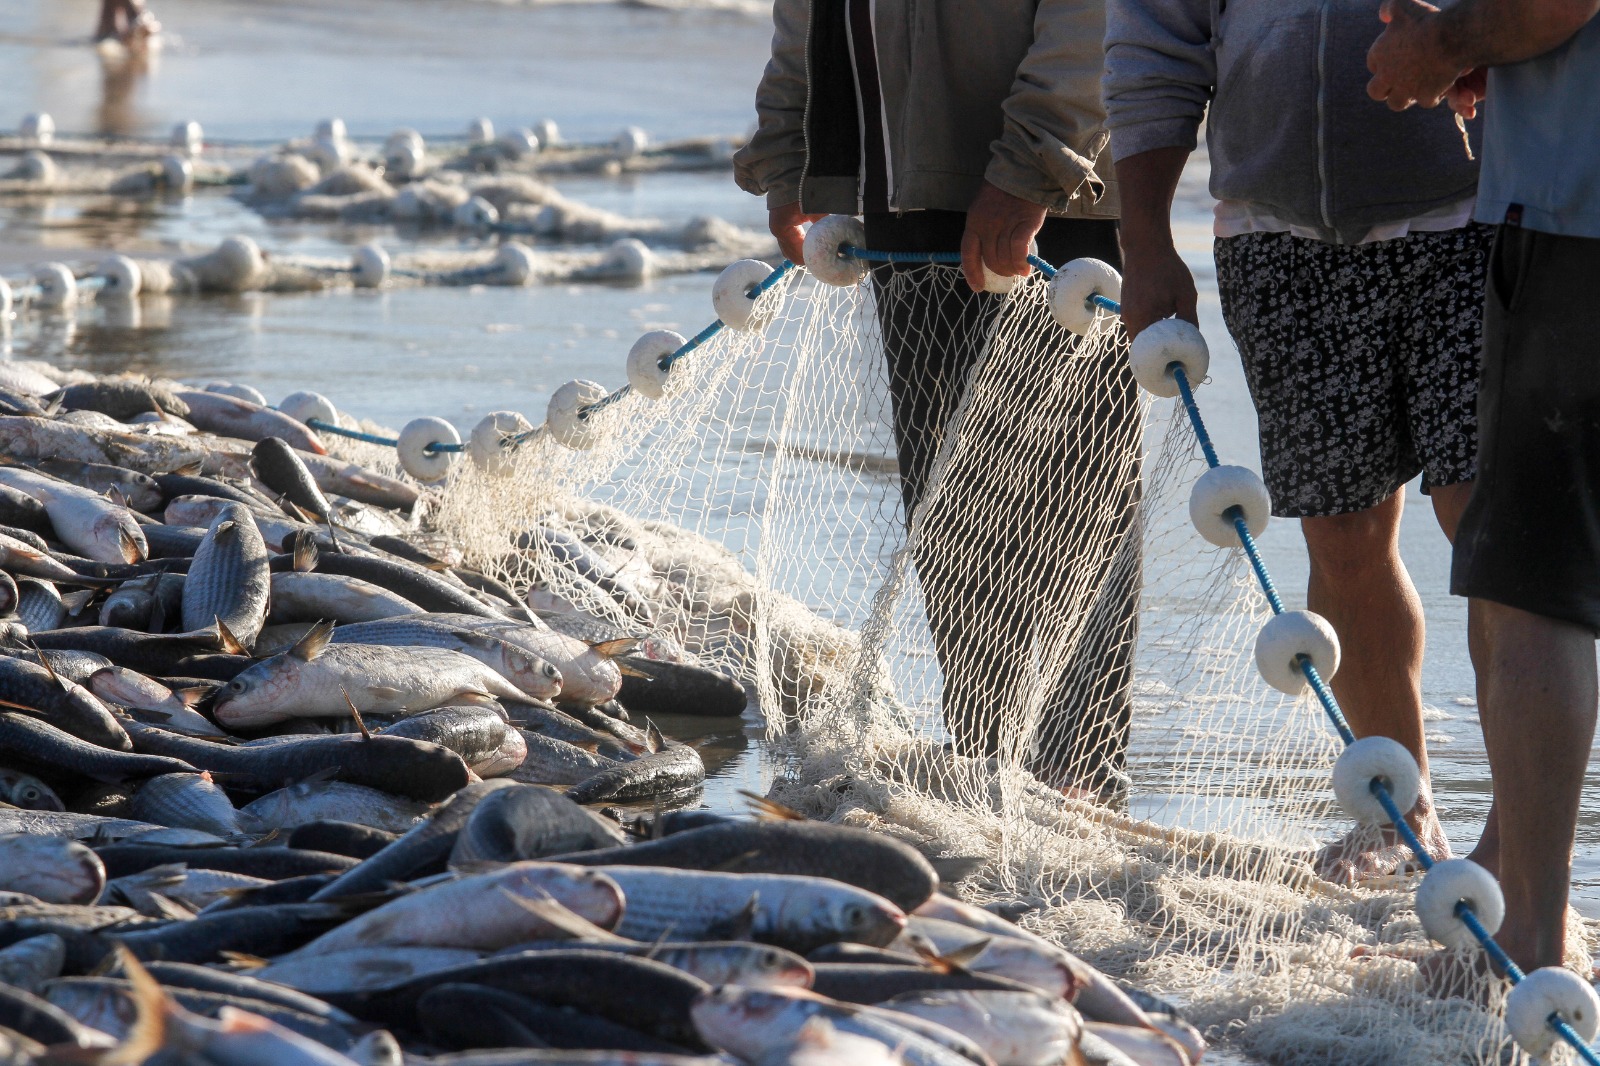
[1104,0,1478,243]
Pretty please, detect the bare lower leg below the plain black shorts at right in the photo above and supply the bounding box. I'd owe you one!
[1477,600,1595,968]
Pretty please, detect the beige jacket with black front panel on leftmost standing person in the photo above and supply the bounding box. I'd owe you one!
[734,0,1117,218]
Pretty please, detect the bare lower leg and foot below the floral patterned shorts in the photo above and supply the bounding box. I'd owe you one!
[1301,490,1459,884]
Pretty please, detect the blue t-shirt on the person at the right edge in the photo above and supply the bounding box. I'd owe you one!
[1477,18,1600,237]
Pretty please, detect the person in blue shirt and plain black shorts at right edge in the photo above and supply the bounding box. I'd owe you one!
[1368,0,1600,970]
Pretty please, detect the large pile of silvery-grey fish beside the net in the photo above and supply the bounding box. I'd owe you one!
[0,363,1205,1066]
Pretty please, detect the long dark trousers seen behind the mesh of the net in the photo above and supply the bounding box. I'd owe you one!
[866,211,1141,792]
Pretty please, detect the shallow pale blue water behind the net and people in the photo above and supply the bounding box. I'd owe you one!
[0,0,1600,941]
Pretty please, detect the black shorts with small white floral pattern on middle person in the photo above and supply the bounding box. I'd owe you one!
[1216,222,1494,519]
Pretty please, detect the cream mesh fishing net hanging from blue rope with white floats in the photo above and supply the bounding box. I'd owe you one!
[412,251,1589,1066]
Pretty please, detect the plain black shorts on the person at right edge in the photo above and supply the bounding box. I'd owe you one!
[1450,226,1600,631]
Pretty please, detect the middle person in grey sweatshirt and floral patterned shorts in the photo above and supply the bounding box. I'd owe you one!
[1106,0,1491,882]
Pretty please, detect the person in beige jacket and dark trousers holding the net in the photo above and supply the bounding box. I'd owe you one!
[734,0,1139,797]
